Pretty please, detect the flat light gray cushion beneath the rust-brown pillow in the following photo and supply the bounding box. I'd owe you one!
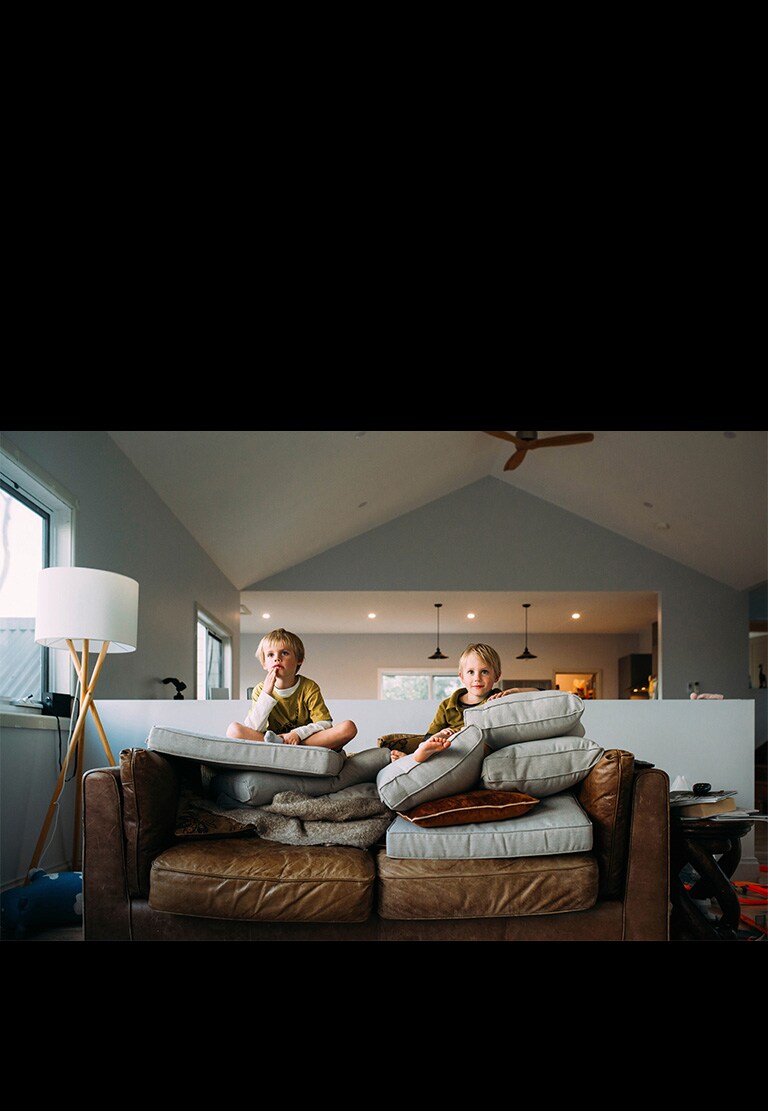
[387,793,592,860]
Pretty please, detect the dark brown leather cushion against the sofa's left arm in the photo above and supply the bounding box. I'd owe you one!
[120,749,180,898]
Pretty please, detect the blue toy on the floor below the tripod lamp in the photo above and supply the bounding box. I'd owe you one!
[0,868,82,941]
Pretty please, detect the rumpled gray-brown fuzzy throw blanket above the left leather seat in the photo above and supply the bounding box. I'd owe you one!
[190,783,395,849]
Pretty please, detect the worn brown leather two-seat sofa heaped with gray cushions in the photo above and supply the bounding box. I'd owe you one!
[83,749,669,942]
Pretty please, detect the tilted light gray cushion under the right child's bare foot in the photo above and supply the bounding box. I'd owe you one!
[376,725,485,810]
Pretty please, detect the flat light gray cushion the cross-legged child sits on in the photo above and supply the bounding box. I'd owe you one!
[147,725,347,775]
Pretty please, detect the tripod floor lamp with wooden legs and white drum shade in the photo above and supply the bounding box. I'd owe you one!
[31,567,139,882]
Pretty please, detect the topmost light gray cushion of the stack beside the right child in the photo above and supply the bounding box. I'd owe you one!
[463,691,584,749]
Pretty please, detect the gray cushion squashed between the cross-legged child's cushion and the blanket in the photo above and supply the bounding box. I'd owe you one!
[210,745,389,807]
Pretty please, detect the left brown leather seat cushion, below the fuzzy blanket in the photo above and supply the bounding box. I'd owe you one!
[149,838,375,922]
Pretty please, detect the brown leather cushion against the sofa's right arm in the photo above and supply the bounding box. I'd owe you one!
[573,749,635,899]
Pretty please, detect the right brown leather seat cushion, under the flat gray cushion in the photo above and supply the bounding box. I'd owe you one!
[377,848,598,919]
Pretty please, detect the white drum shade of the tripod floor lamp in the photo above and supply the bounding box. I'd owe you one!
[34,567,139,652]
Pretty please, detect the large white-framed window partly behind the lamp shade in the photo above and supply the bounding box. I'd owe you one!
[0,447,74,702]
